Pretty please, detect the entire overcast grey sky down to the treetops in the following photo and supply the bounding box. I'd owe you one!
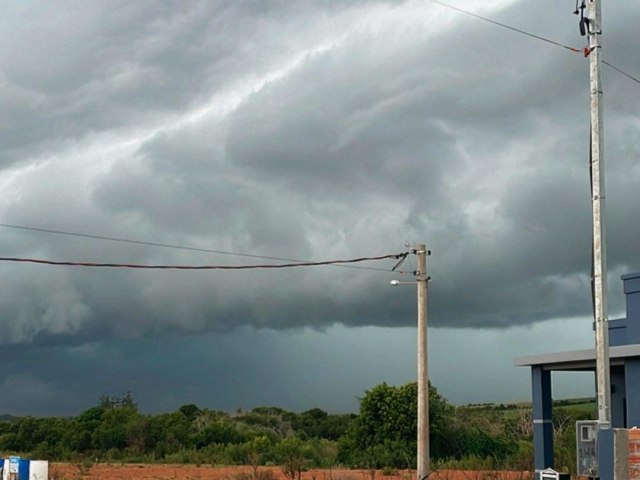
[0,0,640,415]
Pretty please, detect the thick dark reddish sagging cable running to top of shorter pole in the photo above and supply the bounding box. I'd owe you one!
[0,252,407,270]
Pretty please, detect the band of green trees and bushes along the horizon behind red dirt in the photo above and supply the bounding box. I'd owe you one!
[0,383,590,471]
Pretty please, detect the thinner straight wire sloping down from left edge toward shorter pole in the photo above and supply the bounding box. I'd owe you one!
[0,223,389,272]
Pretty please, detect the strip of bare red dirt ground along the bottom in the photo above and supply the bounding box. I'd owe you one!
[49,463,532,480]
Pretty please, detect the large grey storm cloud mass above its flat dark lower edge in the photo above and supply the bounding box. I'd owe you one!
[0,2,640,345]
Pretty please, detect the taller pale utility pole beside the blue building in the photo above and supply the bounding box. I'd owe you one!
[587,0,611,428]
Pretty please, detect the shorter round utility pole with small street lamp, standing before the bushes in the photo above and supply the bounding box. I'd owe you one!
[415,244,429,480]
